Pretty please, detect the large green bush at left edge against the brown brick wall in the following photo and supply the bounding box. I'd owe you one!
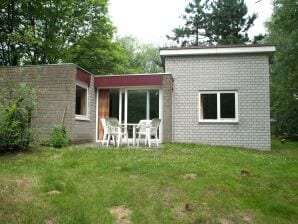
[0,81,36,151]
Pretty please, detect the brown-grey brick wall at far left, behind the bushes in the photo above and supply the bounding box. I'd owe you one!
[0,64,77,141]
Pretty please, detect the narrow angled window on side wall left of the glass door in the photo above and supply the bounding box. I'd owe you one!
[75,85,88,119]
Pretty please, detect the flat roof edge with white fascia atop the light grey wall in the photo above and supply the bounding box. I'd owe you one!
[159,44,276,57]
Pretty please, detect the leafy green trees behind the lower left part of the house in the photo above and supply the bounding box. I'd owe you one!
[0,0,162,75]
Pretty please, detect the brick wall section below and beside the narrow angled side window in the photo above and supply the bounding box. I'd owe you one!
[72,75,96,143]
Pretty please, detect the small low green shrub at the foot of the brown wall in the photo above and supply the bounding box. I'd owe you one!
[42,125,70,148]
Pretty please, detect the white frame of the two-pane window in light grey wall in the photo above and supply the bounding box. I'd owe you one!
[198,90,239,123]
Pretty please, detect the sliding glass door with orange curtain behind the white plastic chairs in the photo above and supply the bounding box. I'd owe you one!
[98,88,162,139]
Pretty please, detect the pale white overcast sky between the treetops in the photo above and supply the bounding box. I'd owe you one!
[109,0,273,46]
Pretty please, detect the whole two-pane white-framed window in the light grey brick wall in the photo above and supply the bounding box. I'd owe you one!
[199,91,238,122]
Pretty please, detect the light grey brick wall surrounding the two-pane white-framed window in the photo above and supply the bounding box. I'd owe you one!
[165,55,270,150]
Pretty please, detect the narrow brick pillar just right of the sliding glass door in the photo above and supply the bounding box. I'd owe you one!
[162,74,173,142]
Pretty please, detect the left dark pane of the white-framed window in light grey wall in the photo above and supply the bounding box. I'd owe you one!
[200,93,217,119]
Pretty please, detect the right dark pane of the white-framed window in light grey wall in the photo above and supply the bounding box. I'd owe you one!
[220,93,235,118]
